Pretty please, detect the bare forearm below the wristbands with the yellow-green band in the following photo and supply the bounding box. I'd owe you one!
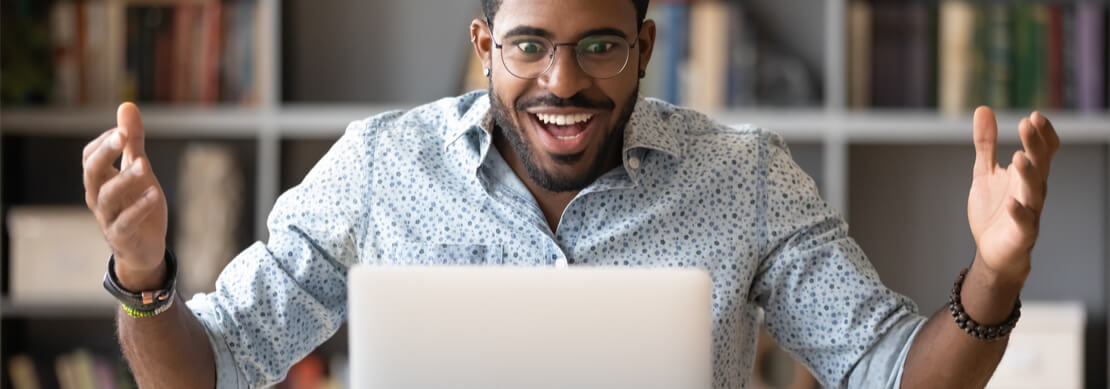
[117,296,215,388]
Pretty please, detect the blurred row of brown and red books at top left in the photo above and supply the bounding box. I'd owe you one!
[0,0,264,107]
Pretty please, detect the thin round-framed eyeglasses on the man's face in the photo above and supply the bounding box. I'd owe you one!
[487,24,636,79]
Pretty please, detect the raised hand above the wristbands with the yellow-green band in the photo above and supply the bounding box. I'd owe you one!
[81,102,167,291]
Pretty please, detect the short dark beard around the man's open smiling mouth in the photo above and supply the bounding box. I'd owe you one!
[490,86,639,192]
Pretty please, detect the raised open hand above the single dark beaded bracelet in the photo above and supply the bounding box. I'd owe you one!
[968,107,1060,282]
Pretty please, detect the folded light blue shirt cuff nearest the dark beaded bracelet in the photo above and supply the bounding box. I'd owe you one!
[848,315,926,388]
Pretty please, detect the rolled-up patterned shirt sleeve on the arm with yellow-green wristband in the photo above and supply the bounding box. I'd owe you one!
[181,119,374,389]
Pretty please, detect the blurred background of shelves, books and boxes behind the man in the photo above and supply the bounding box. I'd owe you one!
[0,0,1110,389]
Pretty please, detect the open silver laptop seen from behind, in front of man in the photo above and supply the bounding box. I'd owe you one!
[347,266,713,388]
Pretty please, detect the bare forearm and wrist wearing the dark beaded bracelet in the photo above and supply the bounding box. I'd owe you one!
[901,258,1021,388]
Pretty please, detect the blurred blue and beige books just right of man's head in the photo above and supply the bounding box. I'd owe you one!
[640,0,819,112]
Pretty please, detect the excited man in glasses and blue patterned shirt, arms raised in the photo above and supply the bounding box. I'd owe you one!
[84,0,1059,388]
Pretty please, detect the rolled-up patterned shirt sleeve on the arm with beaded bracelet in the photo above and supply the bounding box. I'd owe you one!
[753,134,925,388]
